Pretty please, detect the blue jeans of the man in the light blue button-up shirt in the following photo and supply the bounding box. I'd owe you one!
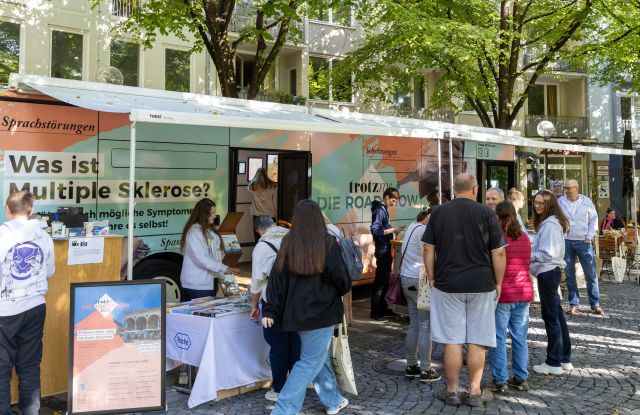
[564,239,600,307]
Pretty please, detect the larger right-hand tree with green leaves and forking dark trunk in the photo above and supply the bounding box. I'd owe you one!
[335,0,640,129]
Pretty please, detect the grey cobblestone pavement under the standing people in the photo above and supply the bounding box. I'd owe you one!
[159,282,640,415]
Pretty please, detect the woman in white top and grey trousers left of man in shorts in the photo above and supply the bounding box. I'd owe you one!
[400,209,440,382]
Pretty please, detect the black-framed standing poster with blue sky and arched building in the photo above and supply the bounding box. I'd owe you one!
[68,280,166,414]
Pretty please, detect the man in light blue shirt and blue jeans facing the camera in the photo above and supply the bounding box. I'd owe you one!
[558,180,604,316]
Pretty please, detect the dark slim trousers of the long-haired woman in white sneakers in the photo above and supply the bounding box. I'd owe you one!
[538,268,571,367]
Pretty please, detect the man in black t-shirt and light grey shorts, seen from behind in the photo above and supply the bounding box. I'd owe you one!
[422,173,507,406]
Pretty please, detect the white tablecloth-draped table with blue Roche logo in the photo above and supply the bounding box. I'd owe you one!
[166,313,271,408]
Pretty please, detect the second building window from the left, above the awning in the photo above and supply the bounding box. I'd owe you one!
[51,30,83,79]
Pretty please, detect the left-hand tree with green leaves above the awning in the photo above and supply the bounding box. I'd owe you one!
[97,0,351,99]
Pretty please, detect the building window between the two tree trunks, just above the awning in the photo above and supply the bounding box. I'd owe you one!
[309,56,353,103]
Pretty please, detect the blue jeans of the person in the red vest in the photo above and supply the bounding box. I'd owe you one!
[489,302,529,383]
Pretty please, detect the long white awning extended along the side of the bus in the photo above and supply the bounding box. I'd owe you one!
[9,74,635,155]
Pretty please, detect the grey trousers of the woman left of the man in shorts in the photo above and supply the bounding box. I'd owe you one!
[400,276,432,370]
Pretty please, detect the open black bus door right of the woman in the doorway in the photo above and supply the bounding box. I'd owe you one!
[278,152,311,223]
